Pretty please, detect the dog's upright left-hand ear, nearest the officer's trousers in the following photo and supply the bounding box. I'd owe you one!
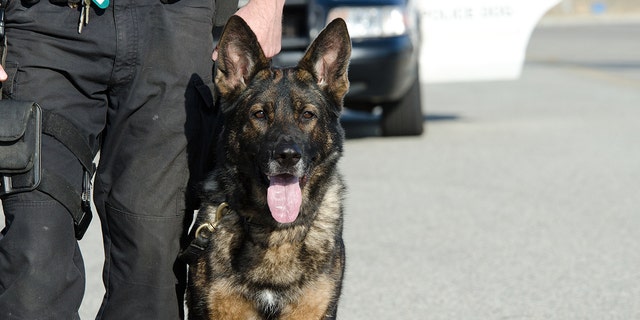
[215,16,270,99]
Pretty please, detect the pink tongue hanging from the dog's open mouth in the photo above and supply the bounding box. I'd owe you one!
[267,175,302,223]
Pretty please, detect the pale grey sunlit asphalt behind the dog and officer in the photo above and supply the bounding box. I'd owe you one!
[0,18,640,320]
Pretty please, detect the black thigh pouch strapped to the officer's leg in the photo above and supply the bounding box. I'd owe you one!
[0,99,42,196]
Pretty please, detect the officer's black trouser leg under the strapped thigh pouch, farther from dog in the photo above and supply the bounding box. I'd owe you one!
[0,1,115,319]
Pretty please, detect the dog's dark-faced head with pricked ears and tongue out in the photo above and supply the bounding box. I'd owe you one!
[215,16,351,223]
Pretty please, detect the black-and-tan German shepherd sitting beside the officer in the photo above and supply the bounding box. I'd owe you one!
[187,16,351,320]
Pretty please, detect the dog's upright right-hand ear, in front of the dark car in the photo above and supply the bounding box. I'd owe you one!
[298,18,351,106]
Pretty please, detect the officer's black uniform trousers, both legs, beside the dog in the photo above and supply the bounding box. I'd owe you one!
[0,0,215,320]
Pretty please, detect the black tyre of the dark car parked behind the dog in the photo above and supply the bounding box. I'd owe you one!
[381,78,424,136]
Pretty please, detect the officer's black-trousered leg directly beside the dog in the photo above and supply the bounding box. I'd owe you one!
[94,0,213,319]
